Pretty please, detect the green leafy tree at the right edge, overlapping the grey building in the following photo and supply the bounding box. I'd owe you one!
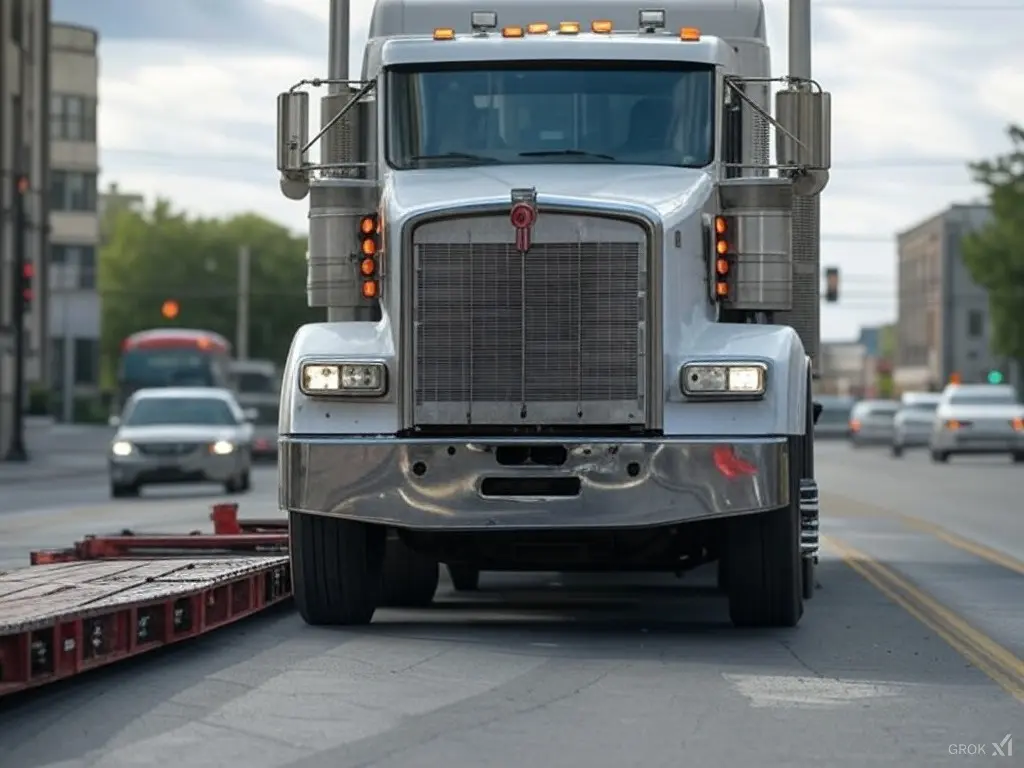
[964,126,1024,360]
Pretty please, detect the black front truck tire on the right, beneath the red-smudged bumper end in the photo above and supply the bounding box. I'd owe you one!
[725,437,804,628]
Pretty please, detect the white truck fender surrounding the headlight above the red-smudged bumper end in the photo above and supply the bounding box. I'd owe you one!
[665,323,808,437]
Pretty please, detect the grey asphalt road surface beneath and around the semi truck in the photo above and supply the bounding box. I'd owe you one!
[0,443,1024,768]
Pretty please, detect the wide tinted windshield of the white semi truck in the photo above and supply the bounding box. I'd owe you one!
[387,61,715,170]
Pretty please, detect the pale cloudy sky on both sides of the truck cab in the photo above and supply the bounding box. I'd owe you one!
[53,0,1024,339]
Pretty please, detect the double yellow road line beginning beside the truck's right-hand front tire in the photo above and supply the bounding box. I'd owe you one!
[822,536,1024,703]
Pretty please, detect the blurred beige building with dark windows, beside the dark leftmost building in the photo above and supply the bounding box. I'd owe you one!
[48,24,100,421]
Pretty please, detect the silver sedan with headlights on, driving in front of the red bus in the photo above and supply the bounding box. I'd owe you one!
[110,387,253,498]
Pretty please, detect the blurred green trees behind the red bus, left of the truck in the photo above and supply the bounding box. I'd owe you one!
[99,201,324,382]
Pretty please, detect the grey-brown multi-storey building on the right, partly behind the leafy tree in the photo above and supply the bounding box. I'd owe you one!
[893,205,1005,390]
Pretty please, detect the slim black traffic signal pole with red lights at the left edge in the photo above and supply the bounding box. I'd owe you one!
[4,48,31,462]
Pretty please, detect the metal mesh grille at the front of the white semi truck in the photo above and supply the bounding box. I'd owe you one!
[414,212,647,425]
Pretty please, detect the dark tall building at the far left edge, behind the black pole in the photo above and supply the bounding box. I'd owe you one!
[0,0,50,457]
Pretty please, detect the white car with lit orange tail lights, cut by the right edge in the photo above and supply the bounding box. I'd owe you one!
[929,384,1024,463]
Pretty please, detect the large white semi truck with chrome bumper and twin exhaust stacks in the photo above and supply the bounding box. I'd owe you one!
[278,0,830,627]
